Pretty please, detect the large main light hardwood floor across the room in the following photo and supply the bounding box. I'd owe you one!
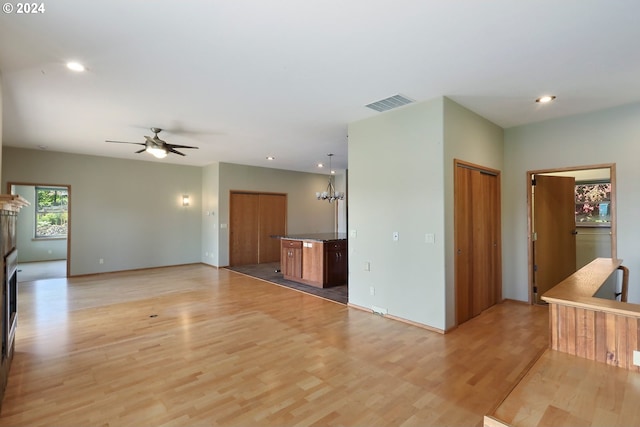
[0,265,548,426]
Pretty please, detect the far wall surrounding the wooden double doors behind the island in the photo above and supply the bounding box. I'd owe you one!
[216,163,344,266]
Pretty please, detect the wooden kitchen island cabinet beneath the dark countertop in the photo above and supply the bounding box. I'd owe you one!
[280,238,348,288]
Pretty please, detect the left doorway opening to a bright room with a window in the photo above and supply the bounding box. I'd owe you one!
[7,182,71,282]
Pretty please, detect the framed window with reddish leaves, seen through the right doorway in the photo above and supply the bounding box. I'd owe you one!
[575,182,611,226]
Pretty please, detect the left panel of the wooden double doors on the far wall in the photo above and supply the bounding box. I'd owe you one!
[229,193,260,266]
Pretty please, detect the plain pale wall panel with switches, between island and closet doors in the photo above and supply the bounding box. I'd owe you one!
[348,98,445,329]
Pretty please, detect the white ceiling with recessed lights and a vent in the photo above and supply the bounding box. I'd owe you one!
[0,0,640,172]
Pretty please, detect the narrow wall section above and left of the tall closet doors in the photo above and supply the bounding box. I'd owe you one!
[444,98,504,328]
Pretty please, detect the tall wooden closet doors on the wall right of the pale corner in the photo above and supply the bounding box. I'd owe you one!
[454,163,502,324]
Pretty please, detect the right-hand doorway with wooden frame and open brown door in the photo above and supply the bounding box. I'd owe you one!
[527,164,617,304]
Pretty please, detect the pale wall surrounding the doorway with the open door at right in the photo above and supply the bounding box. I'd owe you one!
[503,104,640,303]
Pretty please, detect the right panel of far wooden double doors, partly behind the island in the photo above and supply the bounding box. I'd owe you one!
[258,194,287,264]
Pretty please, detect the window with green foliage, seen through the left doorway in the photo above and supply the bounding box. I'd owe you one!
[35,187,69,239]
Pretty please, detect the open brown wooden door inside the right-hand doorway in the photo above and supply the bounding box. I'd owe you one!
[532,175,576,303]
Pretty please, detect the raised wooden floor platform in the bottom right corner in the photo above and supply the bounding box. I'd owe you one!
[485,350,640,427]
